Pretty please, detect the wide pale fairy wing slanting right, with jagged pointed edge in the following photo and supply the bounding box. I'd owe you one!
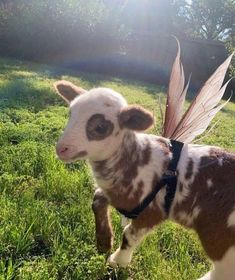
[170,54,233,143]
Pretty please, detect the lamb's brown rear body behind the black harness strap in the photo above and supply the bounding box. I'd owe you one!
[171,143,235,264]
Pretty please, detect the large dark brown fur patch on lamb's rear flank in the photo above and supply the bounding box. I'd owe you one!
[174,148,235,260]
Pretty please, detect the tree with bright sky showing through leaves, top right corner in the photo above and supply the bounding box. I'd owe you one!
[182,0,235,40]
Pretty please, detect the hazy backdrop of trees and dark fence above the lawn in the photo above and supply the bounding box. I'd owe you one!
[0,0,235,91]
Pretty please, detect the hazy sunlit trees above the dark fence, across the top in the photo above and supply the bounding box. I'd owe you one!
[0,0,235,59]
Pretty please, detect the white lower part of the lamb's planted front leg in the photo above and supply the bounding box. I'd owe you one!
[108,223,150,267]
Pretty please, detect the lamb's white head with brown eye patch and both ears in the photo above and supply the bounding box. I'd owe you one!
[55,81,153,162]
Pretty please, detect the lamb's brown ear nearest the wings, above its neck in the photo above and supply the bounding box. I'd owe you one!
[118,105,154,131]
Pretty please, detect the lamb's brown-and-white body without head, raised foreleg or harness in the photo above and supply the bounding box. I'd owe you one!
[91,133,235,280]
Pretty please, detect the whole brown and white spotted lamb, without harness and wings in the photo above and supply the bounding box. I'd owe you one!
[55,81,235,280]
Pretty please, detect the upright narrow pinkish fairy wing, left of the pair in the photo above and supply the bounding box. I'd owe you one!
[163,38,189,138]
